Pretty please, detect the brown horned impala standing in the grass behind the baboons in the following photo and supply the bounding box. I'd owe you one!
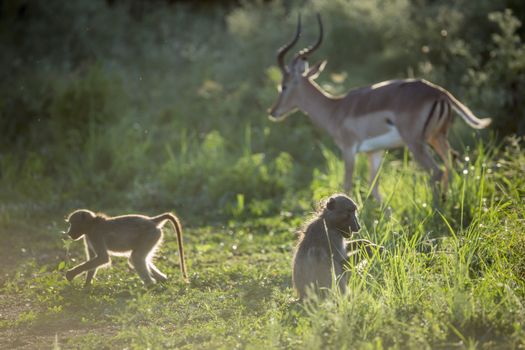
[269,15,491,203]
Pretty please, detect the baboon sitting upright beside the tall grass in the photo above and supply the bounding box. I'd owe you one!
[292,194,361,299]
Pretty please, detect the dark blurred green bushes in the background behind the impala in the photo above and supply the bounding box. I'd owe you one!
[0,0,525,220]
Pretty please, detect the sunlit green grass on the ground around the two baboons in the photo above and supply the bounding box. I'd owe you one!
[0,136,525,349]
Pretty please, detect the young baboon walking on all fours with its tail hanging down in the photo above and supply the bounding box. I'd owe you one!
[66,209,188,286]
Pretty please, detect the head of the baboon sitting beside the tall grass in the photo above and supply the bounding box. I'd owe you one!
[323,194,361,238]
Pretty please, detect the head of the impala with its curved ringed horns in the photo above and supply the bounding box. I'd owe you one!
[269,14,326,121]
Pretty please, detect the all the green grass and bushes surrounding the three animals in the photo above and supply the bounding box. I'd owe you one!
[0,0,525,349]
